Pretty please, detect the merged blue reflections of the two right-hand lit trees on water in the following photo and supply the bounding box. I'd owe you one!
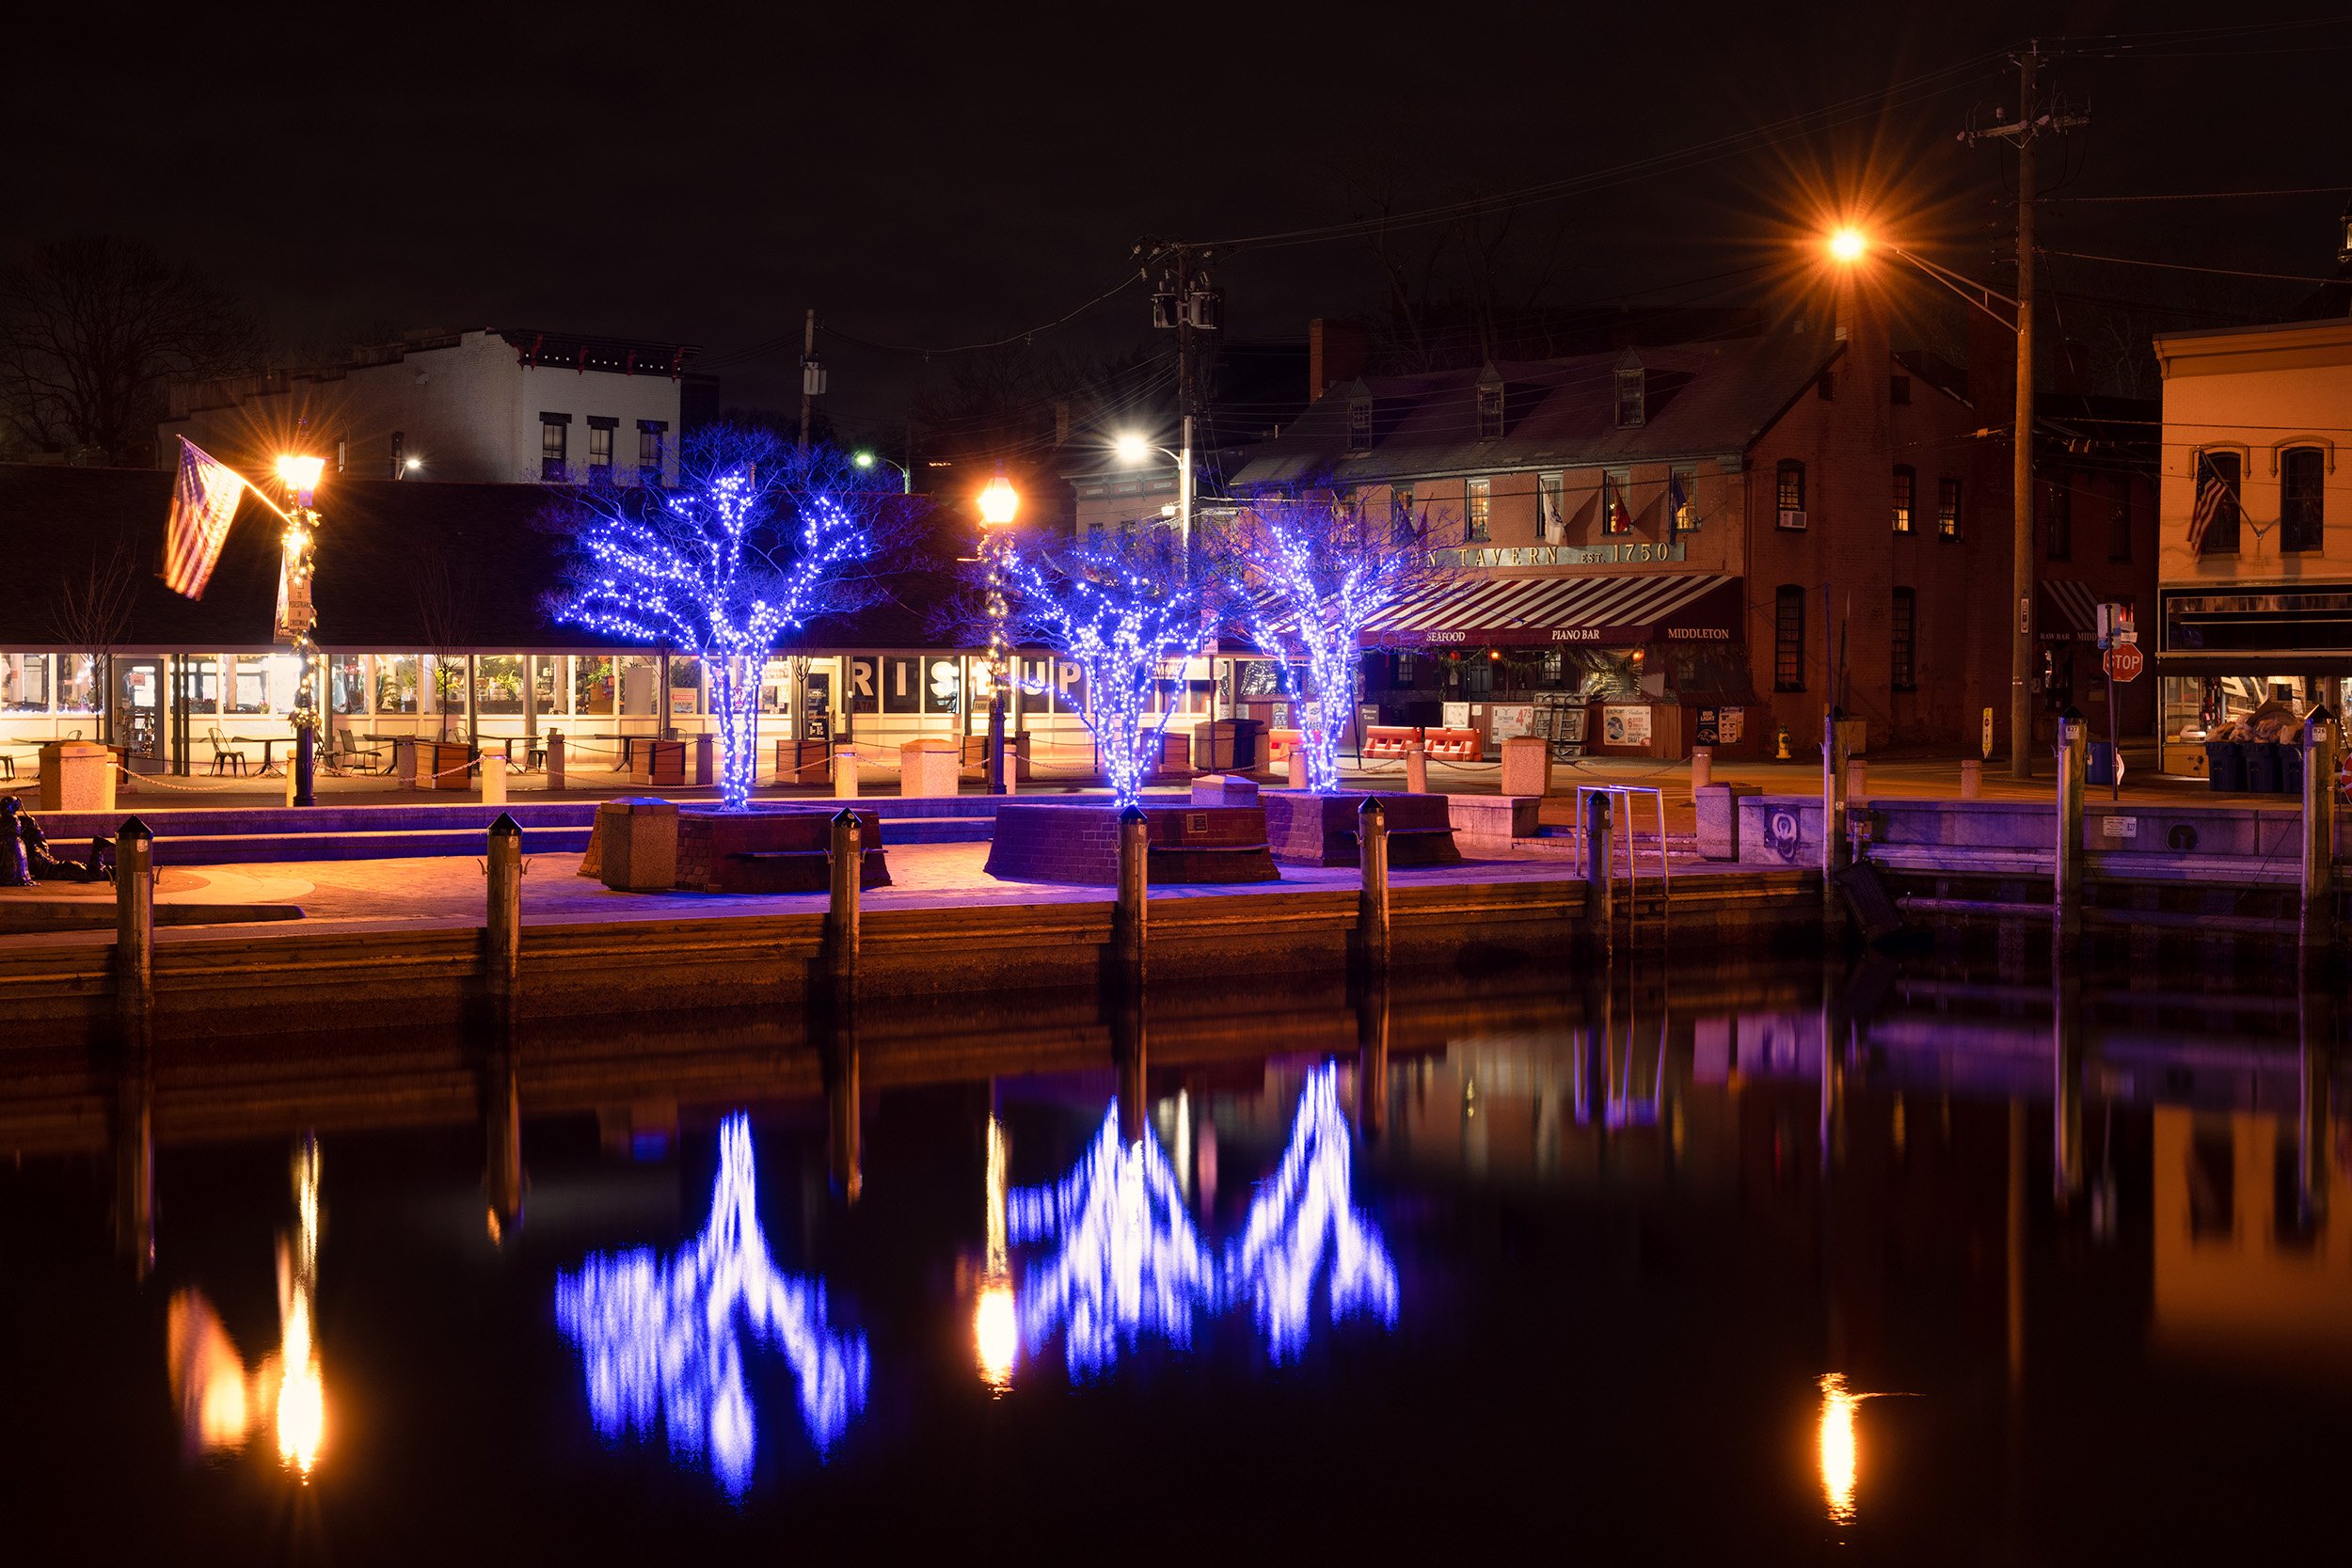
[1007,1063,1397,1378]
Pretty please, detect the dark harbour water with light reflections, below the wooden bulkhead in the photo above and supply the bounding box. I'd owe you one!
[0,966,2352,1563]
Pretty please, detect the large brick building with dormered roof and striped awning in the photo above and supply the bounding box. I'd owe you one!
[1235,287,2154,757]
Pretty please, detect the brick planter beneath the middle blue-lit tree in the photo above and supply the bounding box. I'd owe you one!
[988,801,1282,886]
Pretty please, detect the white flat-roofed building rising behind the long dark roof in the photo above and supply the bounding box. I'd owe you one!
[155,326,715,484]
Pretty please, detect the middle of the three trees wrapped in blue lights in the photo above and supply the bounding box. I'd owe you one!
[1005,529,1218,806]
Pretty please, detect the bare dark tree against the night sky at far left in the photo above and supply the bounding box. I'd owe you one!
[0,235,259,463]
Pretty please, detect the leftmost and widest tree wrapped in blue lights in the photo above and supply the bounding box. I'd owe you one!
[546,425,913,811]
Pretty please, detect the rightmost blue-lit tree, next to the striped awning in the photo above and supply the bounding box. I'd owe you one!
[1204,489,1463,792]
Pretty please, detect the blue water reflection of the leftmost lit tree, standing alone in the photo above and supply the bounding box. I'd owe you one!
[555,1115,870,1497]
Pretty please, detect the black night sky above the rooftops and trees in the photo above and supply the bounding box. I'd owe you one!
[0,0,2352,433]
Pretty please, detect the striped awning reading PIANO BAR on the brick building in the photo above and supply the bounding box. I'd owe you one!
[1242,571,1748,649]
